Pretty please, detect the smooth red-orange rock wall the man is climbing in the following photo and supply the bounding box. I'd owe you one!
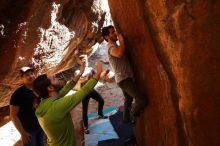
[109,0,220,146]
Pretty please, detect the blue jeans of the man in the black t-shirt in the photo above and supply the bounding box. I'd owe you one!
[24,128,45,146]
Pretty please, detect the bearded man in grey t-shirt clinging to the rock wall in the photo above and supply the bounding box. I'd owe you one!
[102,25,147,123]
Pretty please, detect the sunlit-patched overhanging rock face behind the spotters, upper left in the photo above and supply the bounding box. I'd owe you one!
[0,0,105,107]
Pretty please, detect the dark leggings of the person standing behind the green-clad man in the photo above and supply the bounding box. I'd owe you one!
[82,89,104,127]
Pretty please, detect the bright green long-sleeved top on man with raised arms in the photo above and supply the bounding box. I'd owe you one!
[35,78,97,146]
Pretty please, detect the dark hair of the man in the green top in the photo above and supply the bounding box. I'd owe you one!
[33,74,51,99]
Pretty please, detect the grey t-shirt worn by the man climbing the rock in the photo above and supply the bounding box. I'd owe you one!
[106,43,133,83]
